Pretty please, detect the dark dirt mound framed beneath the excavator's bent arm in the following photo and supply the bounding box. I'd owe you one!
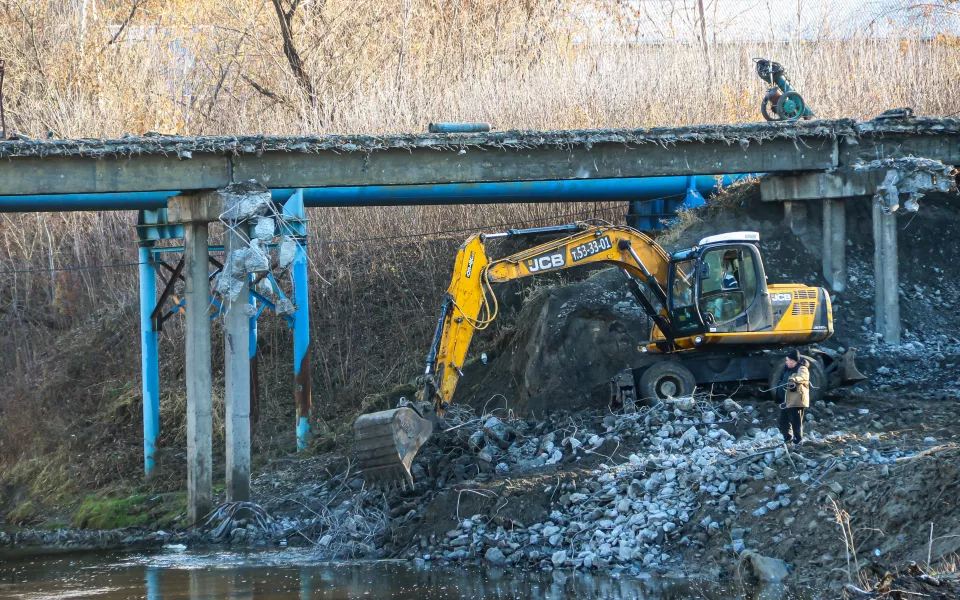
[456,269,650,416]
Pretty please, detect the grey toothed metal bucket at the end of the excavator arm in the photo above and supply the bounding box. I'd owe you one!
[353,407,433,489]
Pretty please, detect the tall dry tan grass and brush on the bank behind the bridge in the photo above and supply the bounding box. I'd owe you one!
[0,0,960,510]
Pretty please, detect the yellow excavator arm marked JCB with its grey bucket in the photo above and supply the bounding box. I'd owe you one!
[354,223,672,487]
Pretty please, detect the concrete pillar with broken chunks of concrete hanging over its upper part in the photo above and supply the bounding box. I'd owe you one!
[223,223,250,502]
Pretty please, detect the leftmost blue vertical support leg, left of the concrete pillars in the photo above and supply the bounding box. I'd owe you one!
[138,242,160,478]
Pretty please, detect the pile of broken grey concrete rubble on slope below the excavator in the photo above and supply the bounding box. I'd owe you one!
[404,398,791,569]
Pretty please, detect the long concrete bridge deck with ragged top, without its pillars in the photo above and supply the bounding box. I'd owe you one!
[0,118,960,196]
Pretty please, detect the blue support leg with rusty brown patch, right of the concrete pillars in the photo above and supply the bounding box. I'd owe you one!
[283,189,313,452]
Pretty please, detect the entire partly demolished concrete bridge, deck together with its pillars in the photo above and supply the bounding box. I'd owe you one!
[0,118,960,522]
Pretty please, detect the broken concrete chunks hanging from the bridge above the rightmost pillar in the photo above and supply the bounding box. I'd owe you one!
[854,158,956,213]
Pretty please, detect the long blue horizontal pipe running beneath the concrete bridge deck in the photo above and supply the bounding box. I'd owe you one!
[0,175,756,212]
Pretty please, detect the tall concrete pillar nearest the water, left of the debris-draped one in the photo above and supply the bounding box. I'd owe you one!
[183,221,213,525]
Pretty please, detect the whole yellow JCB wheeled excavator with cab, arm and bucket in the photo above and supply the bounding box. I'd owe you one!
[354,223,864,488]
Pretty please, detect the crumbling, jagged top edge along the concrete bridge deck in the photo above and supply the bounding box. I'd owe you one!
[0,117,960,160]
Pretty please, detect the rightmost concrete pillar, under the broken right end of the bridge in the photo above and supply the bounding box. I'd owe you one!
[873,201,900,344]
